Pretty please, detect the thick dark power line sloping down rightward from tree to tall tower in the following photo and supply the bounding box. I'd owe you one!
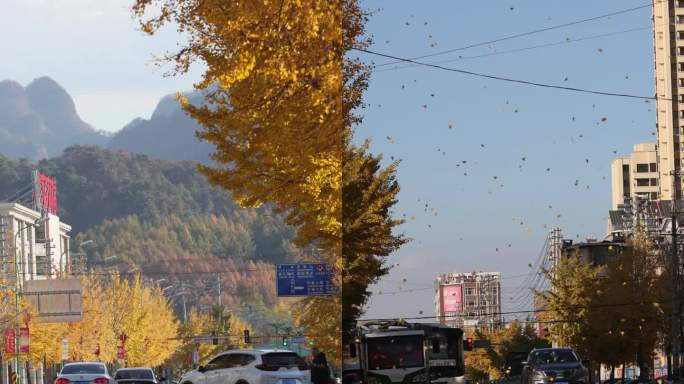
[353,48,656,100]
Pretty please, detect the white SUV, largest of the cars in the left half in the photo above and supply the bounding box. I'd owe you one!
[180,349,311,384]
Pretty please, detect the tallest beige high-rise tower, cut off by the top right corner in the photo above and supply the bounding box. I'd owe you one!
[653,0,684,200]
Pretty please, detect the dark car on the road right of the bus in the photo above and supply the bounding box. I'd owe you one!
[520,348,589,384]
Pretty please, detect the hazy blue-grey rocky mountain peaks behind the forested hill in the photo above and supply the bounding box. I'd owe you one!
[0,77,212,163]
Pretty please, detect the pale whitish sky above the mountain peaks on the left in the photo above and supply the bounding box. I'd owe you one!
[0,0,197,131]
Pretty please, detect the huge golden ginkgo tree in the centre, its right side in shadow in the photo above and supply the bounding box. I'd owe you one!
[132,0,404,362]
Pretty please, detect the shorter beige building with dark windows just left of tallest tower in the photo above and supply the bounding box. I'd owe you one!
[610,143,660,210]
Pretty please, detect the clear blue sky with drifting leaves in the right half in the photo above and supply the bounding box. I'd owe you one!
[357,0,655,318]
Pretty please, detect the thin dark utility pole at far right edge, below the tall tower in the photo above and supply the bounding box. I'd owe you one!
[670,170,681,378]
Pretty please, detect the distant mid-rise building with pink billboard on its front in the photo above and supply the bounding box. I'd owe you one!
[435,272,501,330]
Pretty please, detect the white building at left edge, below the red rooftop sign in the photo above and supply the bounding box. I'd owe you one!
[0,203,71,280]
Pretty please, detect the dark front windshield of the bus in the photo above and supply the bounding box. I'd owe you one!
[367,335,425,371]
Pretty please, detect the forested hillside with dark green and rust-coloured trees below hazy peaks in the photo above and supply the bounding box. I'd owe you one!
[0,146,300,326]
